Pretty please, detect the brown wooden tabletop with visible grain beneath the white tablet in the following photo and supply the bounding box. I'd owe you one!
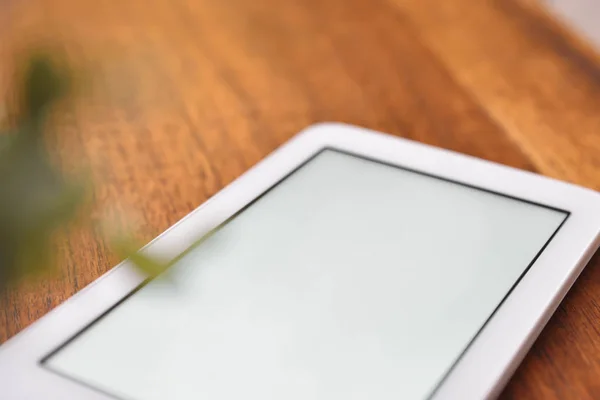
[0,0,600,399]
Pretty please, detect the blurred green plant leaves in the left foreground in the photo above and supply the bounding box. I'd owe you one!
[0,52,164,291]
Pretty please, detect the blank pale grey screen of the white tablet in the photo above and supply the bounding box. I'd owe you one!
[44,149,568,400]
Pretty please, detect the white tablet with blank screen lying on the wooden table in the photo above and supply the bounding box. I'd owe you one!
[0,124,600,400]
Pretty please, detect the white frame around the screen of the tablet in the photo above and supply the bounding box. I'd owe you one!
[0,123,600,400]
